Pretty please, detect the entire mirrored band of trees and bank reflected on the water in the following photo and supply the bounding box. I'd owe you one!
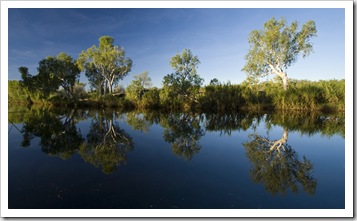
[9,106,345,177]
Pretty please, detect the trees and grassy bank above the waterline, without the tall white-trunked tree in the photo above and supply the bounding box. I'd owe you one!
[9,36,345,112]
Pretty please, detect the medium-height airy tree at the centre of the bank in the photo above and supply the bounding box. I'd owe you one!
[163,49,203,102]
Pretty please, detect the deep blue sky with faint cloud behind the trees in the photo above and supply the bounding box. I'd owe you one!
[8,8,345,87]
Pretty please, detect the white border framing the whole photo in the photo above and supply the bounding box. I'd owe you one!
[0,1,354,217]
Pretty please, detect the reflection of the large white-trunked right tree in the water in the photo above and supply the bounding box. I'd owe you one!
[243,128,317,195]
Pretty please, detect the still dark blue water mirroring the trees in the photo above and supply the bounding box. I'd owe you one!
[8,109,345,209]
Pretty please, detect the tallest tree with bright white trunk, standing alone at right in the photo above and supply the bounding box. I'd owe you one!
[242,17,317,90]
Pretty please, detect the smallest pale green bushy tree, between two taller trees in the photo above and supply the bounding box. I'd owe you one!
[126,71,152,100]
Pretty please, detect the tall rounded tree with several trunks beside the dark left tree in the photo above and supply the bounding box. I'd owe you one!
[78,36,133,95]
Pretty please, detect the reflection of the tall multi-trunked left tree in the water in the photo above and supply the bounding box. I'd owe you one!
[79,113,134,173]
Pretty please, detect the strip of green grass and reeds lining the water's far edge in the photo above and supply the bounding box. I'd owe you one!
[9,80,345,112]
